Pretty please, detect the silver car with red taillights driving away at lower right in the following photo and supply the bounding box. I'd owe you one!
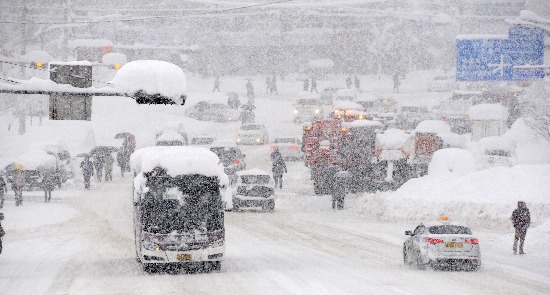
[403,220,481,271]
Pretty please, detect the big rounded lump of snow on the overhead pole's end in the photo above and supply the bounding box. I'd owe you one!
[111,60,187,104]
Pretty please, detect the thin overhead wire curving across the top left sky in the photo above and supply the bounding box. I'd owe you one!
[0,0,293,25]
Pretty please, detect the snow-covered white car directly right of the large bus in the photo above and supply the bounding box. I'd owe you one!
[233,169,275,212]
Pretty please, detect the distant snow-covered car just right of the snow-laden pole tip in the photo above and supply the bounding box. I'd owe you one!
[185,101,240,122]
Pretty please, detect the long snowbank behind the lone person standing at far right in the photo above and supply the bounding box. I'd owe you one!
[358,165,550,229]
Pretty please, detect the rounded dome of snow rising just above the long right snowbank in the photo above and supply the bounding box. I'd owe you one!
[428,148,476,176]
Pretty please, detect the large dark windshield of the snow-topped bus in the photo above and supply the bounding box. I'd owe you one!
[141,170,223,234]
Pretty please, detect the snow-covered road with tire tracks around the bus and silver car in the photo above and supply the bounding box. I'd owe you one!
[0,162,550,294]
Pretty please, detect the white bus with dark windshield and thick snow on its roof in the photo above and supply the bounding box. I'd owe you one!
[131,146,229,272]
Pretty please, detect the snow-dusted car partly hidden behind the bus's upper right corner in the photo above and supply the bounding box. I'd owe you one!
[210,140,246,183]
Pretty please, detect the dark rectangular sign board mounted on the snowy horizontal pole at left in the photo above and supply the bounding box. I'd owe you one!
[49,63,92,121]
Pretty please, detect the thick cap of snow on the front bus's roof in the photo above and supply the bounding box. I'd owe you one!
[130,146,224,177]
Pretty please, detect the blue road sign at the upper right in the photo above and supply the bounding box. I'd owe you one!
[456,26,544,81]
